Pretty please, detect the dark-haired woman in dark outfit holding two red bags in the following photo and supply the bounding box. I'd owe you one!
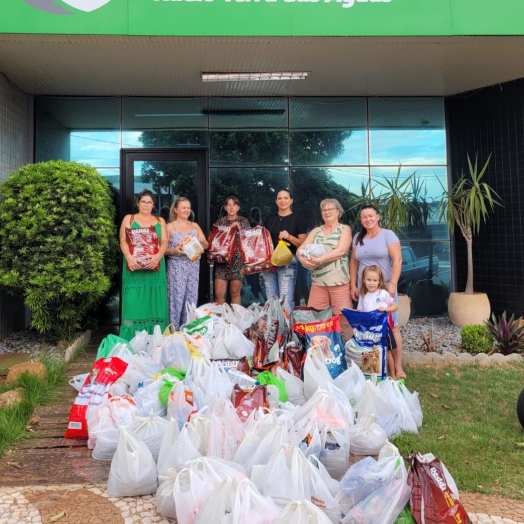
[214,196,249,304]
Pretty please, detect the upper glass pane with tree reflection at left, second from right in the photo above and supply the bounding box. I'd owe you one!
[290,98,368,166]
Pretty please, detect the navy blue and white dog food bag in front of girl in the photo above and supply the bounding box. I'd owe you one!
[342,308,388,380]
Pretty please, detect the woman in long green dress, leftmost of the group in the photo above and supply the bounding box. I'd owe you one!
[120,189,169,340]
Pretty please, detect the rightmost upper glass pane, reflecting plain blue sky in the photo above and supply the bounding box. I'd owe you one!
[369,98,446,165]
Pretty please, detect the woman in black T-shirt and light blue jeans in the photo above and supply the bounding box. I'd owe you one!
[263,189,307,313]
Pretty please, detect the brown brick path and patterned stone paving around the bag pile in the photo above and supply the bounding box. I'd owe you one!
[0,333,524,524]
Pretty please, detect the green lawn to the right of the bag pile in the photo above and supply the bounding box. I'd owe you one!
[393,363,524,500]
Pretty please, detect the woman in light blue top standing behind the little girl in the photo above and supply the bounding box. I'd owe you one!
[349,205,406,380]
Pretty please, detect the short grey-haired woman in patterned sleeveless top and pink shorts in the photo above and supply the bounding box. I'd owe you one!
[297,198,352,319]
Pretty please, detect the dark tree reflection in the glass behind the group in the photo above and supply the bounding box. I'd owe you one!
[139,130,351,225]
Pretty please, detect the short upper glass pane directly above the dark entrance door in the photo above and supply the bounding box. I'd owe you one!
[122,98,207,148]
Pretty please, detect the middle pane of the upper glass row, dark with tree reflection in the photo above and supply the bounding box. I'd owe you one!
[209,98,288,167]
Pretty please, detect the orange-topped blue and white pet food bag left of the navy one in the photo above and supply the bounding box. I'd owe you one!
[293,315,347,378]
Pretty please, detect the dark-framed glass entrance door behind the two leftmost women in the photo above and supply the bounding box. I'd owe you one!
[120,148,211,320]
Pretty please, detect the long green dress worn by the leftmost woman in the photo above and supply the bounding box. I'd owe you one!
[120,221,169,340]
